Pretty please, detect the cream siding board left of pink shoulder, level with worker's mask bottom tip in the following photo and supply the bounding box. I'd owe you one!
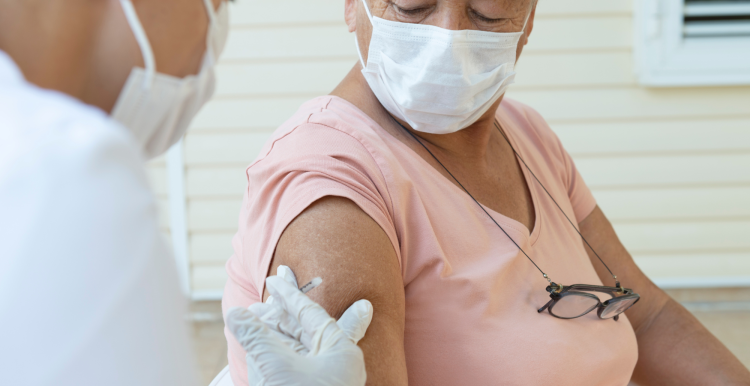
[185,133,272,166]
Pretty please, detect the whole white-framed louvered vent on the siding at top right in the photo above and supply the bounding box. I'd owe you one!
[633,0,750,87]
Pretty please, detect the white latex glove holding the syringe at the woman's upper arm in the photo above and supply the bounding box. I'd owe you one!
[227,276,372,386]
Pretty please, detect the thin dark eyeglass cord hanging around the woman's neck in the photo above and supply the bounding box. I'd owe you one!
[388,114,620,288]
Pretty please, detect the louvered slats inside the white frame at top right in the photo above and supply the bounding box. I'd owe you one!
[682,0,750,39]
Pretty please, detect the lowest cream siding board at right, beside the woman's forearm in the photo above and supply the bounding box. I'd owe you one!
[626,250,750,280]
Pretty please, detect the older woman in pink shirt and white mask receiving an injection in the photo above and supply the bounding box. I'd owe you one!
[224,0,750,385]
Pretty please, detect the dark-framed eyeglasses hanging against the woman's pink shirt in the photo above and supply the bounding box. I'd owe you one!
[537,283,641,321]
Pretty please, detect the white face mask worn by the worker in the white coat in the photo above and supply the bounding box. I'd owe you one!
[112,0,229,158]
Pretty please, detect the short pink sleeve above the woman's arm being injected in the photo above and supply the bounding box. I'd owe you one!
[235,123,399,297]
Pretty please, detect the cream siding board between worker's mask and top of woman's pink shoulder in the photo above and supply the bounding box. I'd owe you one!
[187,95,316,131]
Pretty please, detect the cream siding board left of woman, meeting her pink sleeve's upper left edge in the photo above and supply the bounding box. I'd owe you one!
[185,166,247,199]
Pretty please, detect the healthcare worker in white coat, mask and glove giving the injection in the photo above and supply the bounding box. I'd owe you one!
[0,0,372,386]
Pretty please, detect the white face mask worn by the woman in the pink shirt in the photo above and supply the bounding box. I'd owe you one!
[355,0,528,134]
